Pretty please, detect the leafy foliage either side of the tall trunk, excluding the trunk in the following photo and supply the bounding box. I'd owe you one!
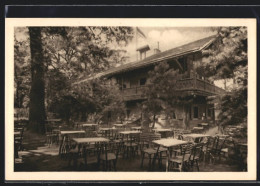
[15,27,133,133]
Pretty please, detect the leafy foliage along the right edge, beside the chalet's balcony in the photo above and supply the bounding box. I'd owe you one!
[197,27,248,125]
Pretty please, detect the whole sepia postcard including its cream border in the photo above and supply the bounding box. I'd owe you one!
[5,18,257,180]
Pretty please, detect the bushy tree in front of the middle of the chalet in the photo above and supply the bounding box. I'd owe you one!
[143,62,192,127]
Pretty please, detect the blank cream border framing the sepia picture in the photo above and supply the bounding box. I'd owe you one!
[5,18,257,181]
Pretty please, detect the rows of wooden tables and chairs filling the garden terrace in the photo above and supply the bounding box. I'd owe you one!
[23,118,247,171]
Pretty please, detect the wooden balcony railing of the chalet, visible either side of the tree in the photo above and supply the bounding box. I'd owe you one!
[122,78,225,101]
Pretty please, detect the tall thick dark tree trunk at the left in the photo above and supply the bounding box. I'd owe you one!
[29,27,46,134]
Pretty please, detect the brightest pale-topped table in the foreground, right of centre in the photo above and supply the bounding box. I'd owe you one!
[153,138,190,172]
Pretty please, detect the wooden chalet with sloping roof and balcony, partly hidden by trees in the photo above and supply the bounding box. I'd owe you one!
[78,36,224,125]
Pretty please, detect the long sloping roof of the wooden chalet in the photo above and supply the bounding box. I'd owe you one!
[78,35,216,83]
